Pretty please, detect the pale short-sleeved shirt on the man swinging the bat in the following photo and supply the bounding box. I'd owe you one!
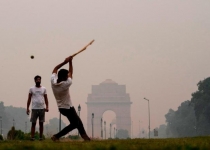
[51,73,73,109]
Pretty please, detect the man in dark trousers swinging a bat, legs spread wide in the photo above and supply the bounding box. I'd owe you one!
[51,56,90,141]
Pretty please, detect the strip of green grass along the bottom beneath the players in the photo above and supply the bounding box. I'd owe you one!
[0,137,210,150]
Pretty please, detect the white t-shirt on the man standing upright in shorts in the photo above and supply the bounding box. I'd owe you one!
[29,86,47,109]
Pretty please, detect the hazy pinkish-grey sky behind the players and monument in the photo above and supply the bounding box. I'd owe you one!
[0,0,210,138]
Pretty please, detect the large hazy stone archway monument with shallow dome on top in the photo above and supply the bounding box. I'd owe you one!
[86,79,132,138]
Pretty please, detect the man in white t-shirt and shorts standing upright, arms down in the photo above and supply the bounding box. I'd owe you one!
[26,75,49,141]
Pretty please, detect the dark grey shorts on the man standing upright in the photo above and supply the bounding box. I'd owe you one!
[30,109,45,123]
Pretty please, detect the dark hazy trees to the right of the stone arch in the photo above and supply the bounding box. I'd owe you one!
[165,77,210,137]
